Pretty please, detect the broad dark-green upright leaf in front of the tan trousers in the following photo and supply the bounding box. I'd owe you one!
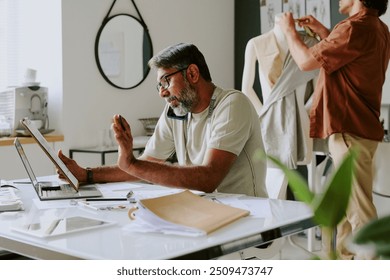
[312,151,357,228]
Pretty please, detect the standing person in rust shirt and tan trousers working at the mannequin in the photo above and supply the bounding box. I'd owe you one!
[279,0,390,259]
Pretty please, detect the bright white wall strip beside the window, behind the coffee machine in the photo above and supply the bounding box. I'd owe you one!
[18,0,62,139]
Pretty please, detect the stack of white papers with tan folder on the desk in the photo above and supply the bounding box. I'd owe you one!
[126,190,250,236]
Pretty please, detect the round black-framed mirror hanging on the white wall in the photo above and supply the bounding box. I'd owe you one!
[95,14,153,89]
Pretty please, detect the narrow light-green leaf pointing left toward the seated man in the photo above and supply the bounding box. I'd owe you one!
[258,153,314,204]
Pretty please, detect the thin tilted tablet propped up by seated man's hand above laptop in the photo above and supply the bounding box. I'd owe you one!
[20,119,79,191]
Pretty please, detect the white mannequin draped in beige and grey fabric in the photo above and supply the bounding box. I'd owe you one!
[242,14,318,198]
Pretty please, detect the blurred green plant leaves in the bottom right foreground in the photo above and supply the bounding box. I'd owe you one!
[256,151,390,259]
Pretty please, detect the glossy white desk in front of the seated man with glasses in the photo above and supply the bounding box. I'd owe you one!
[0,177,314,260]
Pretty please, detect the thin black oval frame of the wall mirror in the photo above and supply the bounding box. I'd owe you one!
[95,14,153,89]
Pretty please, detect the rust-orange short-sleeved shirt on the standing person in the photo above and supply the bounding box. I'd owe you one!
[310,9,390,141]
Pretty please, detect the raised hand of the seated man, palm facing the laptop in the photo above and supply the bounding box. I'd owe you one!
[112,115,135,171]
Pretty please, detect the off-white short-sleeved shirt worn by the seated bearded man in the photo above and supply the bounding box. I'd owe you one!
[144,87,267,197]
